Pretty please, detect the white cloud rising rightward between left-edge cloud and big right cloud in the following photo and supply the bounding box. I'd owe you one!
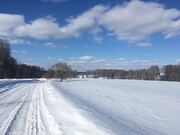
[14,6,106,39]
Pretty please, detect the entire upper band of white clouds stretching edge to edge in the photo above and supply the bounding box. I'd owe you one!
[0,0,180,43]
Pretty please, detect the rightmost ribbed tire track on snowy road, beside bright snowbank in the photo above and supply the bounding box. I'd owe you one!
[24,83,63,135]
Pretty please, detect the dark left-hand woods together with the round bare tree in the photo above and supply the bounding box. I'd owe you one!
[0,39,76,81]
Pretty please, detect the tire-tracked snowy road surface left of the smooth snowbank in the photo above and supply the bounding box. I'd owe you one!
[0,82,63,135]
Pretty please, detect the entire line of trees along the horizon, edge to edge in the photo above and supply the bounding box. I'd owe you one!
[0,39,180,81]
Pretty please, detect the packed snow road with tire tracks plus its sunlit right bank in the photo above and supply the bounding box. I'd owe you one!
[0,81,109,135]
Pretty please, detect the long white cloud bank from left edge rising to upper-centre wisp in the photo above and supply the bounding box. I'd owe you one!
[0,6,105,39]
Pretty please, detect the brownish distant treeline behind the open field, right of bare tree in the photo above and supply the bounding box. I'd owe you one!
[78,65,180,81]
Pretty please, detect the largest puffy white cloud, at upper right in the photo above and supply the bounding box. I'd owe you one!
[99,0,180,42]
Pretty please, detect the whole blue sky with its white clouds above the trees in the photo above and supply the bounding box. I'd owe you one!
[0,0,180,70]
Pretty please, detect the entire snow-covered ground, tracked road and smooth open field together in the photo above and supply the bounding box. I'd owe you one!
[0,79,180,135]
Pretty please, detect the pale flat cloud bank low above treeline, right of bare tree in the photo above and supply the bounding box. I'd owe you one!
[63,56,156,71]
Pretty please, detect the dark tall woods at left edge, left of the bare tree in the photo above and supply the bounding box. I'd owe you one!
[0,39,45,79]
